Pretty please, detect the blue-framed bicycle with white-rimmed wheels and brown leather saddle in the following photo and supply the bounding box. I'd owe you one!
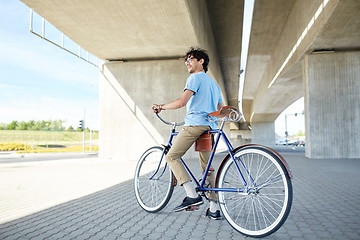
[134,106,293,238]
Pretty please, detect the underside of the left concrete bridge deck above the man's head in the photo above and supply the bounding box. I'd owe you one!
[22,0,244,106]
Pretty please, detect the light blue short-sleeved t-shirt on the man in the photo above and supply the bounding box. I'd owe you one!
[184,72,223,129]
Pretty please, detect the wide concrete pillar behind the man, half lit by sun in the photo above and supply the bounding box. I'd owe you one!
[99,59,188,161]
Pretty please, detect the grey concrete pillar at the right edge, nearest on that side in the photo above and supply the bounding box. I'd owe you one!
[303,52,360,158]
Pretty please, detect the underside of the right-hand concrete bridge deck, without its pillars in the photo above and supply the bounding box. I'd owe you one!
[242,0,360,123]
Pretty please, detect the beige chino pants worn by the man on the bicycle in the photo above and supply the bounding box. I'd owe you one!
[166,126,217,201]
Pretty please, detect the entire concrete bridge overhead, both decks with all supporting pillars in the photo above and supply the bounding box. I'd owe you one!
[21,0,360,159]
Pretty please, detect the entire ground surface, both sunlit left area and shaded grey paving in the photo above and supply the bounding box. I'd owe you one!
[0,146,360,240]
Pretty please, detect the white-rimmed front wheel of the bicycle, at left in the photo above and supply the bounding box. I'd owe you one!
[134,147,174,213]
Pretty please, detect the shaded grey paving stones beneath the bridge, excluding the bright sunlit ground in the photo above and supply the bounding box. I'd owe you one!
[0,151,360,240]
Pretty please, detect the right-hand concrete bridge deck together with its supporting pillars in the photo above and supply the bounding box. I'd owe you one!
[241,0,360,158]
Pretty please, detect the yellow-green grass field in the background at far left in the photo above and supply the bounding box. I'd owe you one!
[0,130,99,153]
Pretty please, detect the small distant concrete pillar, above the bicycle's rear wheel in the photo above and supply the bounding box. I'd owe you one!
[251,122,275,146]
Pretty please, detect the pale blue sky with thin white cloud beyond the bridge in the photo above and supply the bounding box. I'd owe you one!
[0,0,305,137]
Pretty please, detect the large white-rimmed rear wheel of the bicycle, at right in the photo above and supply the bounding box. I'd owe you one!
[218,146,293,237]
